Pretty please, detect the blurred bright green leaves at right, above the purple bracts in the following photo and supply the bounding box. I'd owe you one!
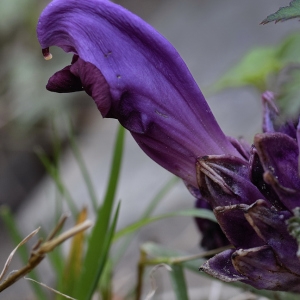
[211,32,300,118]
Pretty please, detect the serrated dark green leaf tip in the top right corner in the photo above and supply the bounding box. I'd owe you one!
[261,0,300,24]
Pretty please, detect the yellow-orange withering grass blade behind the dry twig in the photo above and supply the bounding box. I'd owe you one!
[57,208,87,300]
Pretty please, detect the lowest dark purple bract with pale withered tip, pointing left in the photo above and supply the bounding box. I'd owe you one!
[200,246,300,292]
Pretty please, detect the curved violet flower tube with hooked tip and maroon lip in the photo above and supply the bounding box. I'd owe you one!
[37,0,240,186]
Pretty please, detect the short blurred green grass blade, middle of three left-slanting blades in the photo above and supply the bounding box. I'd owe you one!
[36,149,78,218]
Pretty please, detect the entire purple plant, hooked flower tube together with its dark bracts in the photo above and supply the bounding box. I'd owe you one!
[37,0,300,292]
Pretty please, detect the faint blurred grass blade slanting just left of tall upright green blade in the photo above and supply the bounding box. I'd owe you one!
[69,123,98,211]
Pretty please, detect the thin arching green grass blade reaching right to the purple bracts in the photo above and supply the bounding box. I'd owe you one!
[113,208,216,241]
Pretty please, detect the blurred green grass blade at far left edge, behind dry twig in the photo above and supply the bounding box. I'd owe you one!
[0,206,47,300]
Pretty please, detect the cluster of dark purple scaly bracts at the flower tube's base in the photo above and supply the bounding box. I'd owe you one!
[197,92,300,292]
